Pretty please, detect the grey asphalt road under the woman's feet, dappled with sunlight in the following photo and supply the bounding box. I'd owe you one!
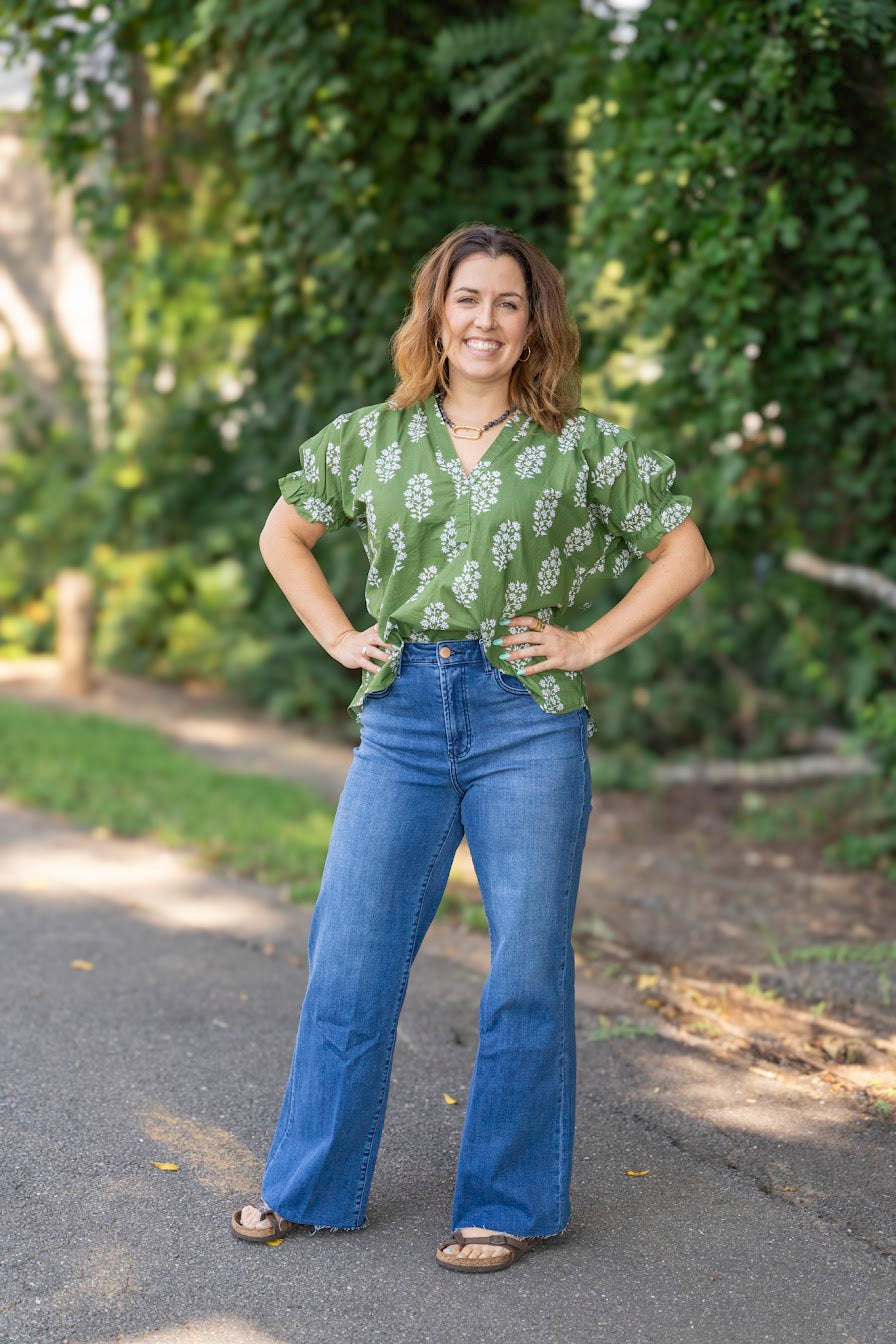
[0,805,896,1344]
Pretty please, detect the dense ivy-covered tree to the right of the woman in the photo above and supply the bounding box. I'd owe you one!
[570,0,896,751]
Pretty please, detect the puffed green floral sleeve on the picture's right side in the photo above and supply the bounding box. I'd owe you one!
[586,421,692,555]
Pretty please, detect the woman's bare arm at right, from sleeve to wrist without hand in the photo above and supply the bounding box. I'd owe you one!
[582,517,715,665]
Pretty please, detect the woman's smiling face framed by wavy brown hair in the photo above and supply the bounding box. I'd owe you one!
[441,253,529,388]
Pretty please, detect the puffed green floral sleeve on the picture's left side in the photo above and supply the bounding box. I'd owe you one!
[278,415,363,532]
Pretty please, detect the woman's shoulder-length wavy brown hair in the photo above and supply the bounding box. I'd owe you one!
[390,224,582,434]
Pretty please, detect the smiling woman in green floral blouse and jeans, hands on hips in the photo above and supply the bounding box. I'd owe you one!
[231,226,713,1273]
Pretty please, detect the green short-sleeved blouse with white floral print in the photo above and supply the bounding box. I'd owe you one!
[279,396,692,737]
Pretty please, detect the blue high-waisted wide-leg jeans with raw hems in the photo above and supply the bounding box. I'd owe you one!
[262,640,591,1236]
